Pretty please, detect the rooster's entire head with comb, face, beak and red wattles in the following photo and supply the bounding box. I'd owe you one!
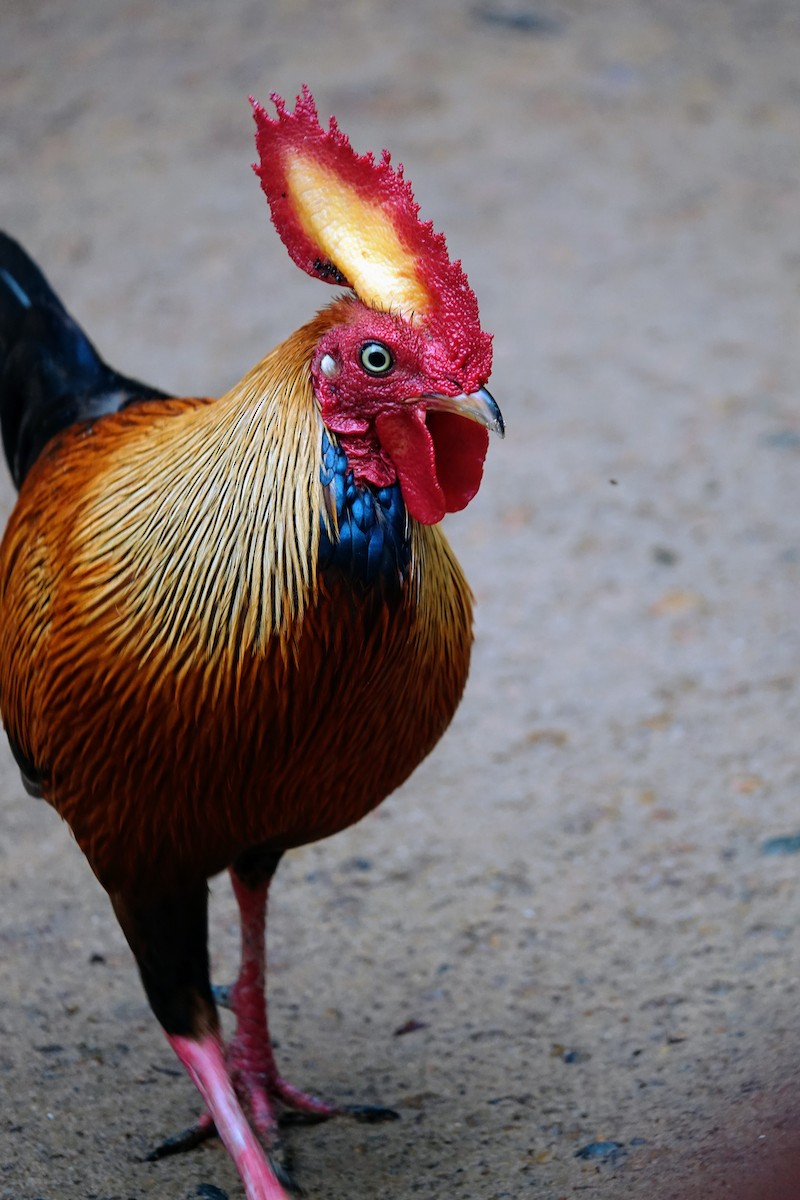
[253,88,503,524]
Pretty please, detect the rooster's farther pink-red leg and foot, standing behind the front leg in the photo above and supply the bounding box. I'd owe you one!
[228,871,342,1145]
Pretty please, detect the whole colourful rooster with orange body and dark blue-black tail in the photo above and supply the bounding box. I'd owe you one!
[0,89,503,1200]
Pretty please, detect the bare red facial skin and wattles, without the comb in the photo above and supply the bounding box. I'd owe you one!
[312,301,488,524]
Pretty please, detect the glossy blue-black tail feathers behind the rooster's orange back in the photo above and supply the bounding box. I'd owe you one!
[0,233,166,487]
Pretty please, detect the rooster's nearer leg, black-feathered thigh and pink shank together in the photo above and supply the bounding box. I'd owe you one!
[112,881,287,1200]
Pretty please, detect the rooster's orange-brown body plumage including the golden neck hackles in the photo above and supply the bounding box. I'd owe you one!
[0,301,471,895]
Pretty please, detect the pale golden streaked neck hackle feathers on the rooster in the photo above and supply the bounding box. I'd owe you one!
[76,301,357,661]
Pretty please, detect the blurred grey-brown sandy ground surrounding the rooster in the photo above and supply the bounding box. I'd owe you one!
[0,0,800,1200]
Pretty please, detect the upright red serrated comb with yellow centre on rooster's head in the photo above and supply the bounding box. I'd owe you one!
[251,85,491,379]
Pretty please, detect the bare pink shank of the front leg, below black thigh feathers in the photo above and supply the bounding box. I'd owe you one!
[168,1033,288,1200]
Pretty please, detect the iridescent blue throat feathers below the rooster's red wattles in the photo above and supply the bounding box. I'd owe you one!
[319,431,411,587]
